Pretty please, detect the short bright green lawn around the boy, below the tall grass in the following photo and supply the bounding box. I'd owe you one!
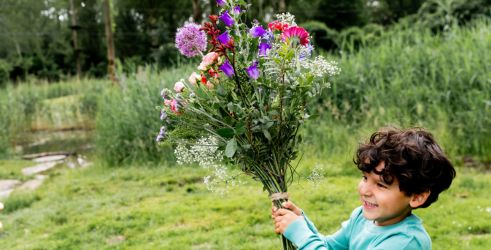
[0,159,491,250]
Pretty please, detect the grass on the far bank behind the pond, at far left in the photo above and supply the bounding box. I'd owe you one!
[0,79,109,158]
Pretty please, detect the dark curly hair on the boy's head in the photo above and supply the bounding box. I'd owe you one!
[354,127,456,207]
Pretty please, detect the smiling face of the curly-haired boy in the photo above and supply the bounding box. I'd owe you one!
[358,161,412,226]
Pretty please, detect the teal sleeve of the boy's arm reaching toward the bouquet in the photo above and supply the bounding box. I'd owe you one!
[283,209,358,250]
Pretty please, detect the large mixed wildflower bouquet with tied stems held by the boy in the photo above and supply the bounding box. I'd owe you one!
[157,0,339,249]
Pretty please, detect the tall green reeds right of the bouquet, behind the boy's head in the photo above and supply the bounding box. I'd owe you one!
[311,20,491,161]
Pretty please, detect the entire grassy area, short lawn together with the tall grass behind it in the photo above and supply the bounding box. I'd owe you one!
[0,11,491,249]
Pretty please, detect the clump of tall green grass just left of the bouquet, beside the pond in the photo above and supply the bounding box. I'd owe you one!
[96,66,194,165]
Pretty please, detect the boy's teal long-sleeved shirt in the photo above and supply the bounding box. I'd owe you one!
[283,207,431,250]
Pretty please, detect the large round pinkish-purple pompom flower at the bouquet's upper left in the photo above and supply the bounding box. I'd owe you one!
[176,23,206,57]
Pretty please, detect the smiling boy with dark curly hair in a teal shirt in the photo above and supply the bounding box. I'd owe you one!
[272,128,455,250]
